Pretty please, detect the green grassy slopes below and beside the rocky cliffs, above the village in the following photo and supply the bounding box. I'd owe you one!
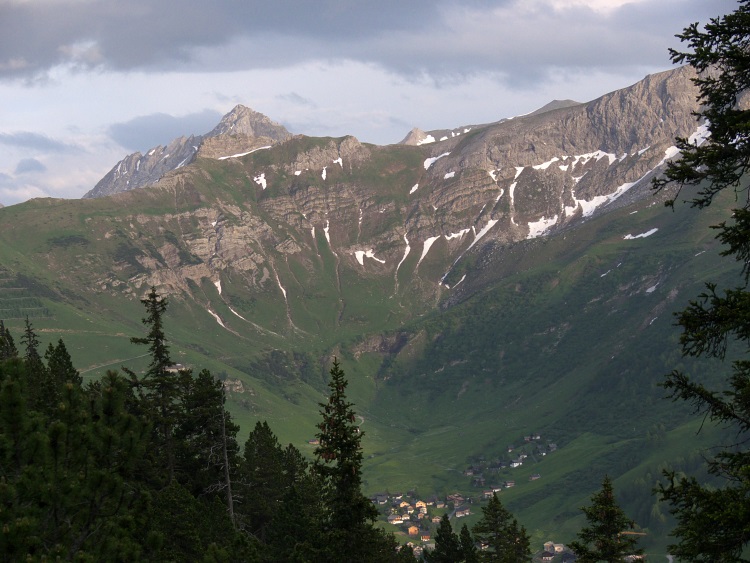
[0,154,736,550]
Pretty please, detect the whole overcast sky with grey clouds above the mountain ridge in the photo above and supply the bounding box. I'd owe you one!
[0,0,737,205]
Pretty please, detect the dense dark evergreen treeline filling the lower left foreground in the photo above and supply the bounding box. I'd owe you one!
[0,289,424,562]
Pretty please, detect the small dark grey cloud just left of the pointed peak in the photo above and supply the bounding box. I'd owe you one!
[108,109,221,151]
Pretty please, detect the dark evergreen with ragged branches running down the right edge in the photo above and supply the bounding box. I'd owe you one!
[654,0,750,562]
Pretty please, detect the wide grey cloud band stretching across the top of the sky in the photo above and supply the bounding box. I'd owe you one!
[0,0,736,84]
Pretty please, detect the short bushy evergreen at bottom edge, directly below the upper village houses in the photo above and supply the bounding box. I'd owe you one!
[472,493,531,563]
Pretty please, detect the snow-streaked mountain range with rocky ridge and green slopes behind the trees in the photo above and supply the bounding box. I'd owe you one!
[0,68,732,549]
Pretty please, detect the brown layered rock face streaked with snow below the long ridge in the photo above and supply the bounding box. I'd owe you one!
[70,68,699,312]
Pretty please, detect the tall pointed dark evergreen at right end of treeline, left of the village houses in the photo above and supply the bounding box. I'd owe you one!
[314,358,382,562]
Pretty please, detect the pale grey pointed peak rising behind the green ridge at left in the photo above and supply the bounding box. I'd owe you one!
[83,105,291,198]
